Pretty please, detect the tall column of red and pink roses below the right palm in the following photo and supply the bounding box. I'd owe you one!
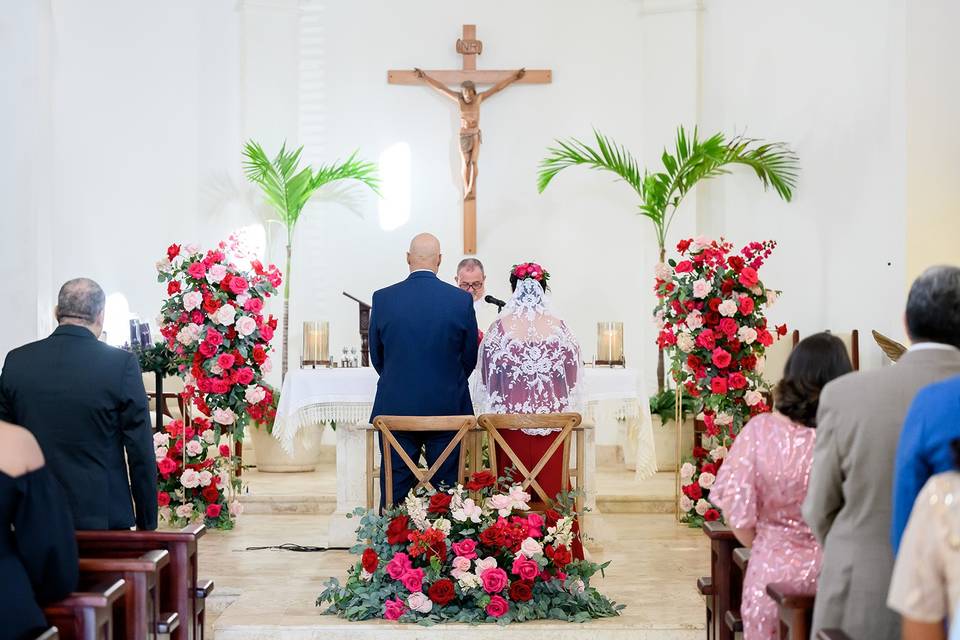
[655,238,787,527]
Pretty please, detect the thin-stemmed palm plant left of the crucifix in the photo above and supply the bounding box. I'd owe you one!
[243,140,379,377]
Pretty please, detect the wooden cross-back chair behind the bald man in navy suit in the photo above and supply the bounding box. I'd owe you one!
[367,416,477,509]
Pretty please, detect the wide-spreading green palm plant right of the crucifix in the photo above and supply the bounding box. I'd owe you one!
[537,126,799,391]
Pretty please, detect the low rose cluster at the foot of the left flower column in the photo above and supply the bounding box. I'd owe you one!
[153,418,242,529]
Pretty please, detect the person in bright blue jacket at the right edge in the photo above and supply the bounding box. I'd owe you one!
[890,370,960,554]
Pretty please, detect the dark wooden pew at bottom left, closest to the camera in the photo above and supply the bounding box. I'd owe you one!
[43,580,127,640]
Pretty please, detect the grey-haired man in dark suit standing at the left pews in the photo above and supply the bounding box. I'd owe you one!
[0,278,157,530]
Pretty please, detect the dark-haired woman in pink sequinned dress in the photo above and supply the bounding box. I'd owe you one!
[710,333,853,640]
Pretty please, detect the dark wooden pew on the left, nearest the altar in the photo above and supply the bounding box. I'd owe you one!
[77,524,214,640]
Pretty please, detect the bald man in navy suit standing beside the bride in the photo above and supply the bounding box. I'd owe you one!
[370,233,479,507]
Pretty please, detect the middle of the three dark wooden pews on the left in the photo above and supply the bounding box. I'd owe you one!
[80,550,180,640]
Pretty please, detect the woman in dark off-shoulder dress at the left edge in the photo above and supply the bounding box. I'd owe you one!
[0,422,78,639]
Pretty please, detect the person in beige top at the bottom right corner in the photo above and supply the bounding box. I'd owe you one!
[887,440,960,640]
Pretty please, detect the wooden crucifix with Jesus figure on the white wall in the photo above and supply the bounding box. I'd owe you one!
[387,24,551,254]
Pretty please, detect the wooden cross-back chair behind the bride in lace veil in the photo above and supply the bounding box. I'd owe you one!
[477,413,583,504]
